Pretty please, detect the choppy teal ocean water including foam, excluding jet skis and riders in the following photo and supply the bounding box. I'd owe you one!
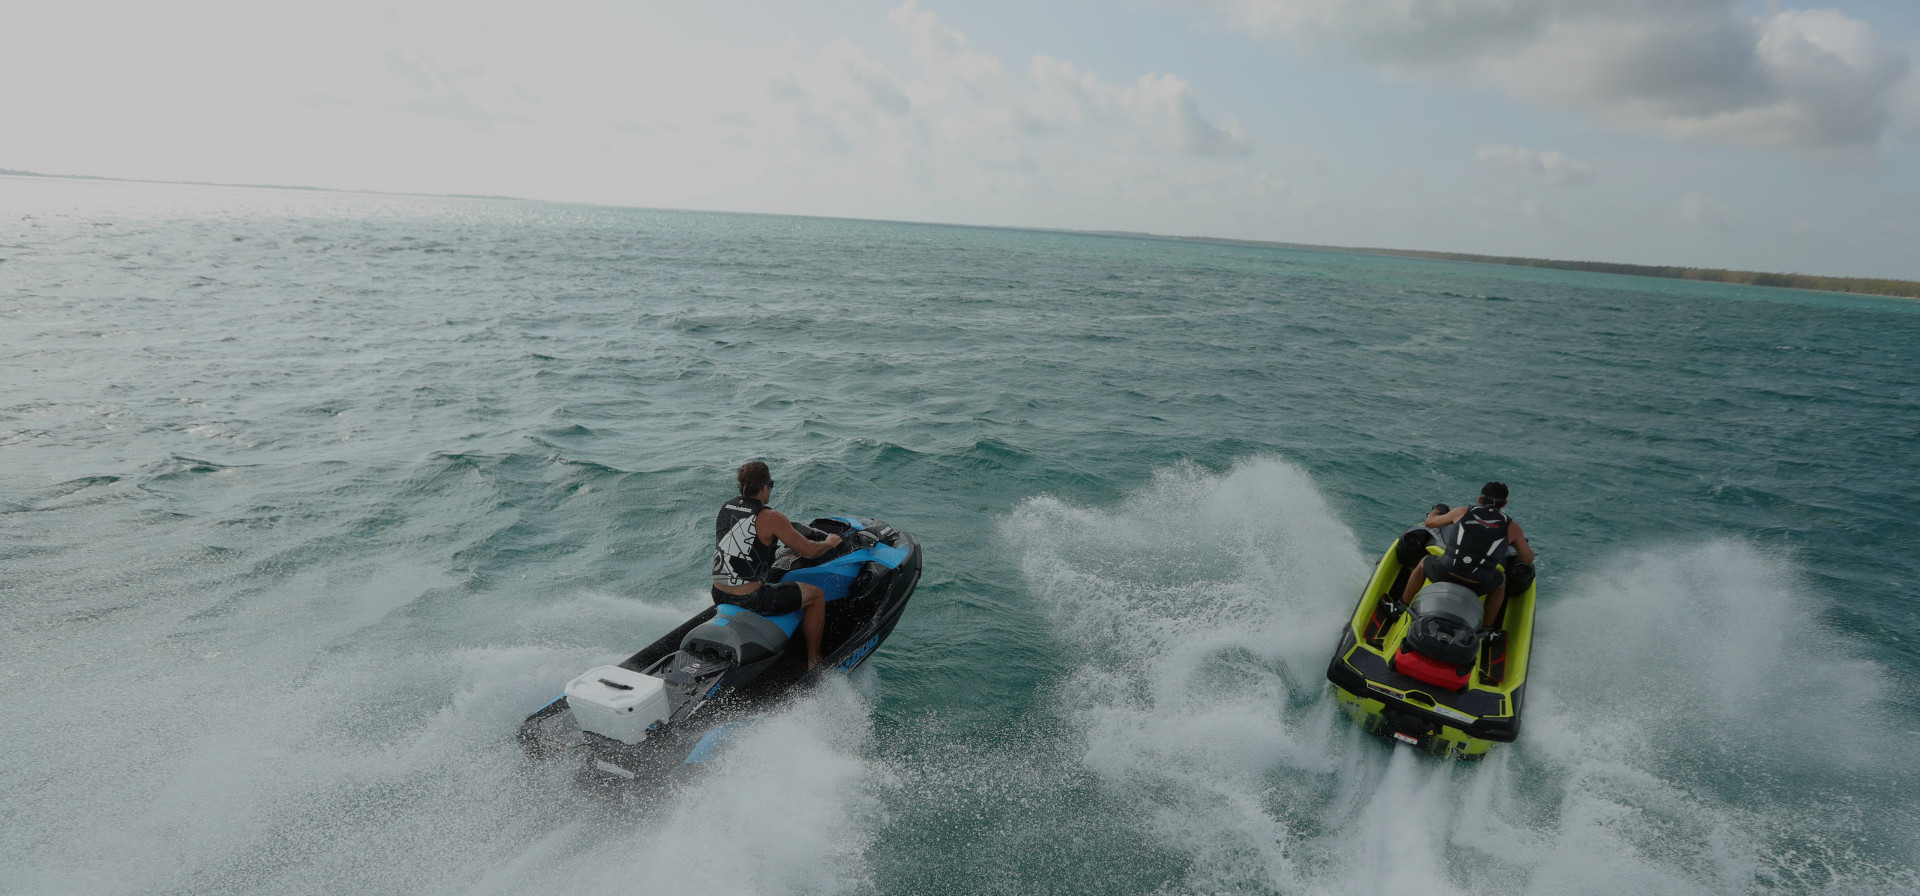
[11,178,1920,896]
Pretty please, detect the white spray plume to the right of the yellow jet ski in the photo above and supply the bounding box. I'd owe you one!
[1517,541,1920,894]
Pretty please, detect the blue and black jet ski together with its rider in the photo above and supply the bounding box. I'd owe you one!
[518,464,920,785]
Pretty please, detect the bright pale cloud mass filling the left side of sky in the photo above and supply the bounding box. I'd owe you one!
[0,0,1252,223]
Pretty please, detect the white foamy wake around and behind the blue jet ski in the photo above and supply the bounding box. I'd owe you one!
[0,571,885,896]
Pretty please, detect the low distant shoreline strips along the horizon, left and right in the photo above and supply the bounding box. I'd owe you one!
[15,169,1920,299]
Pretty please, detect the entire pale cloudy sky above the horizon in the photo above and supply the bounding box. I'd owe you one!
[0,0,1920,278]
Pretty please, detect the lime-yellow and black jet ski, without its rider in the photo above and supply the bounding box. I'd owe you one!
[1327,526,1534,760]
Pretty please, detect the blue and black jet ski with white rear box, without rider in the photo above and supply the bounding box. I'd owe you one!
[518,516,920,787]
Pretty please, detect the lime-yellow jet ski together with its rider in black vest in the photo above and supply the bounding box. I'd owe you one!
[1327,483,1536,758]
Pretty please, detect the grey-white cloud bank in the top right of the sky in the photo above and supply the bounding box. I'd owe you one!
[1192,0,1912,153]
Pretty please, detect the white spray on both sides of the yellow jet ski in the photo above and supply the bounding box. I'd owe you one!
[1008,460,1916,894]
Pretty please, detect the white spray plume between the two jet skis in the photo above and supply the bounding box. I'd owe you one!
[1008,460,1365,890]
